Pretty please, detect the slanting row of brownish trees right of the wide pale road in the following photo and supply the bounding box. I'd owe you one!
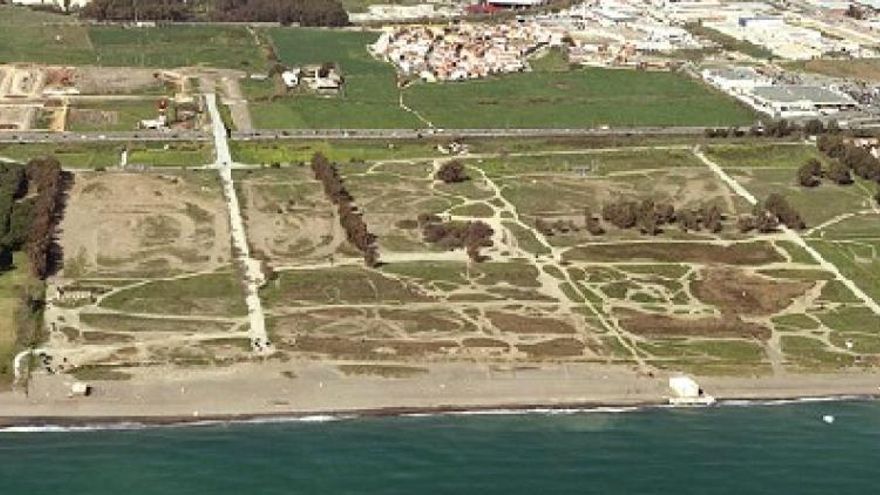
[311,153,379,267]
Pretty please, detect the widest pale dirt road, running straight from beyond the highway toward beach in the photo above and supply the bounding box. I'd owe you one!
[205,93,273,354]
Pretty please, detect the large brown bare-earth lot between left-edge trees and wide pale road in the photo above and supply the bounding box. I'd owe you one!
[58,173,231,276]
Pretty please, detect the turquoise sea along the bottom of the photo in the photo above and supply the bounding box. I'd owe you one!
[0,401,880,495]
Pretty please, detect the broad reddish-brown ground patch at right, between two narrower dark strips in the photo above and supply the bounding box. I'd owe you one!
[691,268,812,315]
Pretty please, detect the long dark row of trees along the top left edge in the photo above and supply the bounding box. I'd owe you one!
[80,0,348,26]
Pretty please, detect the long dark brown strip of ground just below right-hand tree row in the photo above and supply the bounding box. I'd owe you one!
[564,242,785,265]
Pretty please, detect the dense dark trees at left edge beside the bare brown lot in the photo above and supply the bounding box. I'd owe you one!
[0,157,64,279]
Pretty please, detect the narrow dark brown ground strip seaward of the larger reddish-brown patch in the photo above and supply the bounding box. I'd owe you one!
[620,310,770,340]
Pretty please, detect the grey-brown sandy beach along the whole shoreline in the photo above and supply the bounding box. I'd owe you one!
[0,361,880,425]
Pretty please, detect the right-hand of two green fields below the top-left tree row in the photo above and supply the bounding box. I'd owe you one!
[89,26,262,70]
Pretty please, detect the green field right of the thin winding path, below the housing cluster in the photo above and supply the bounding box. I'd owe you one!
[405,68,754,128]
